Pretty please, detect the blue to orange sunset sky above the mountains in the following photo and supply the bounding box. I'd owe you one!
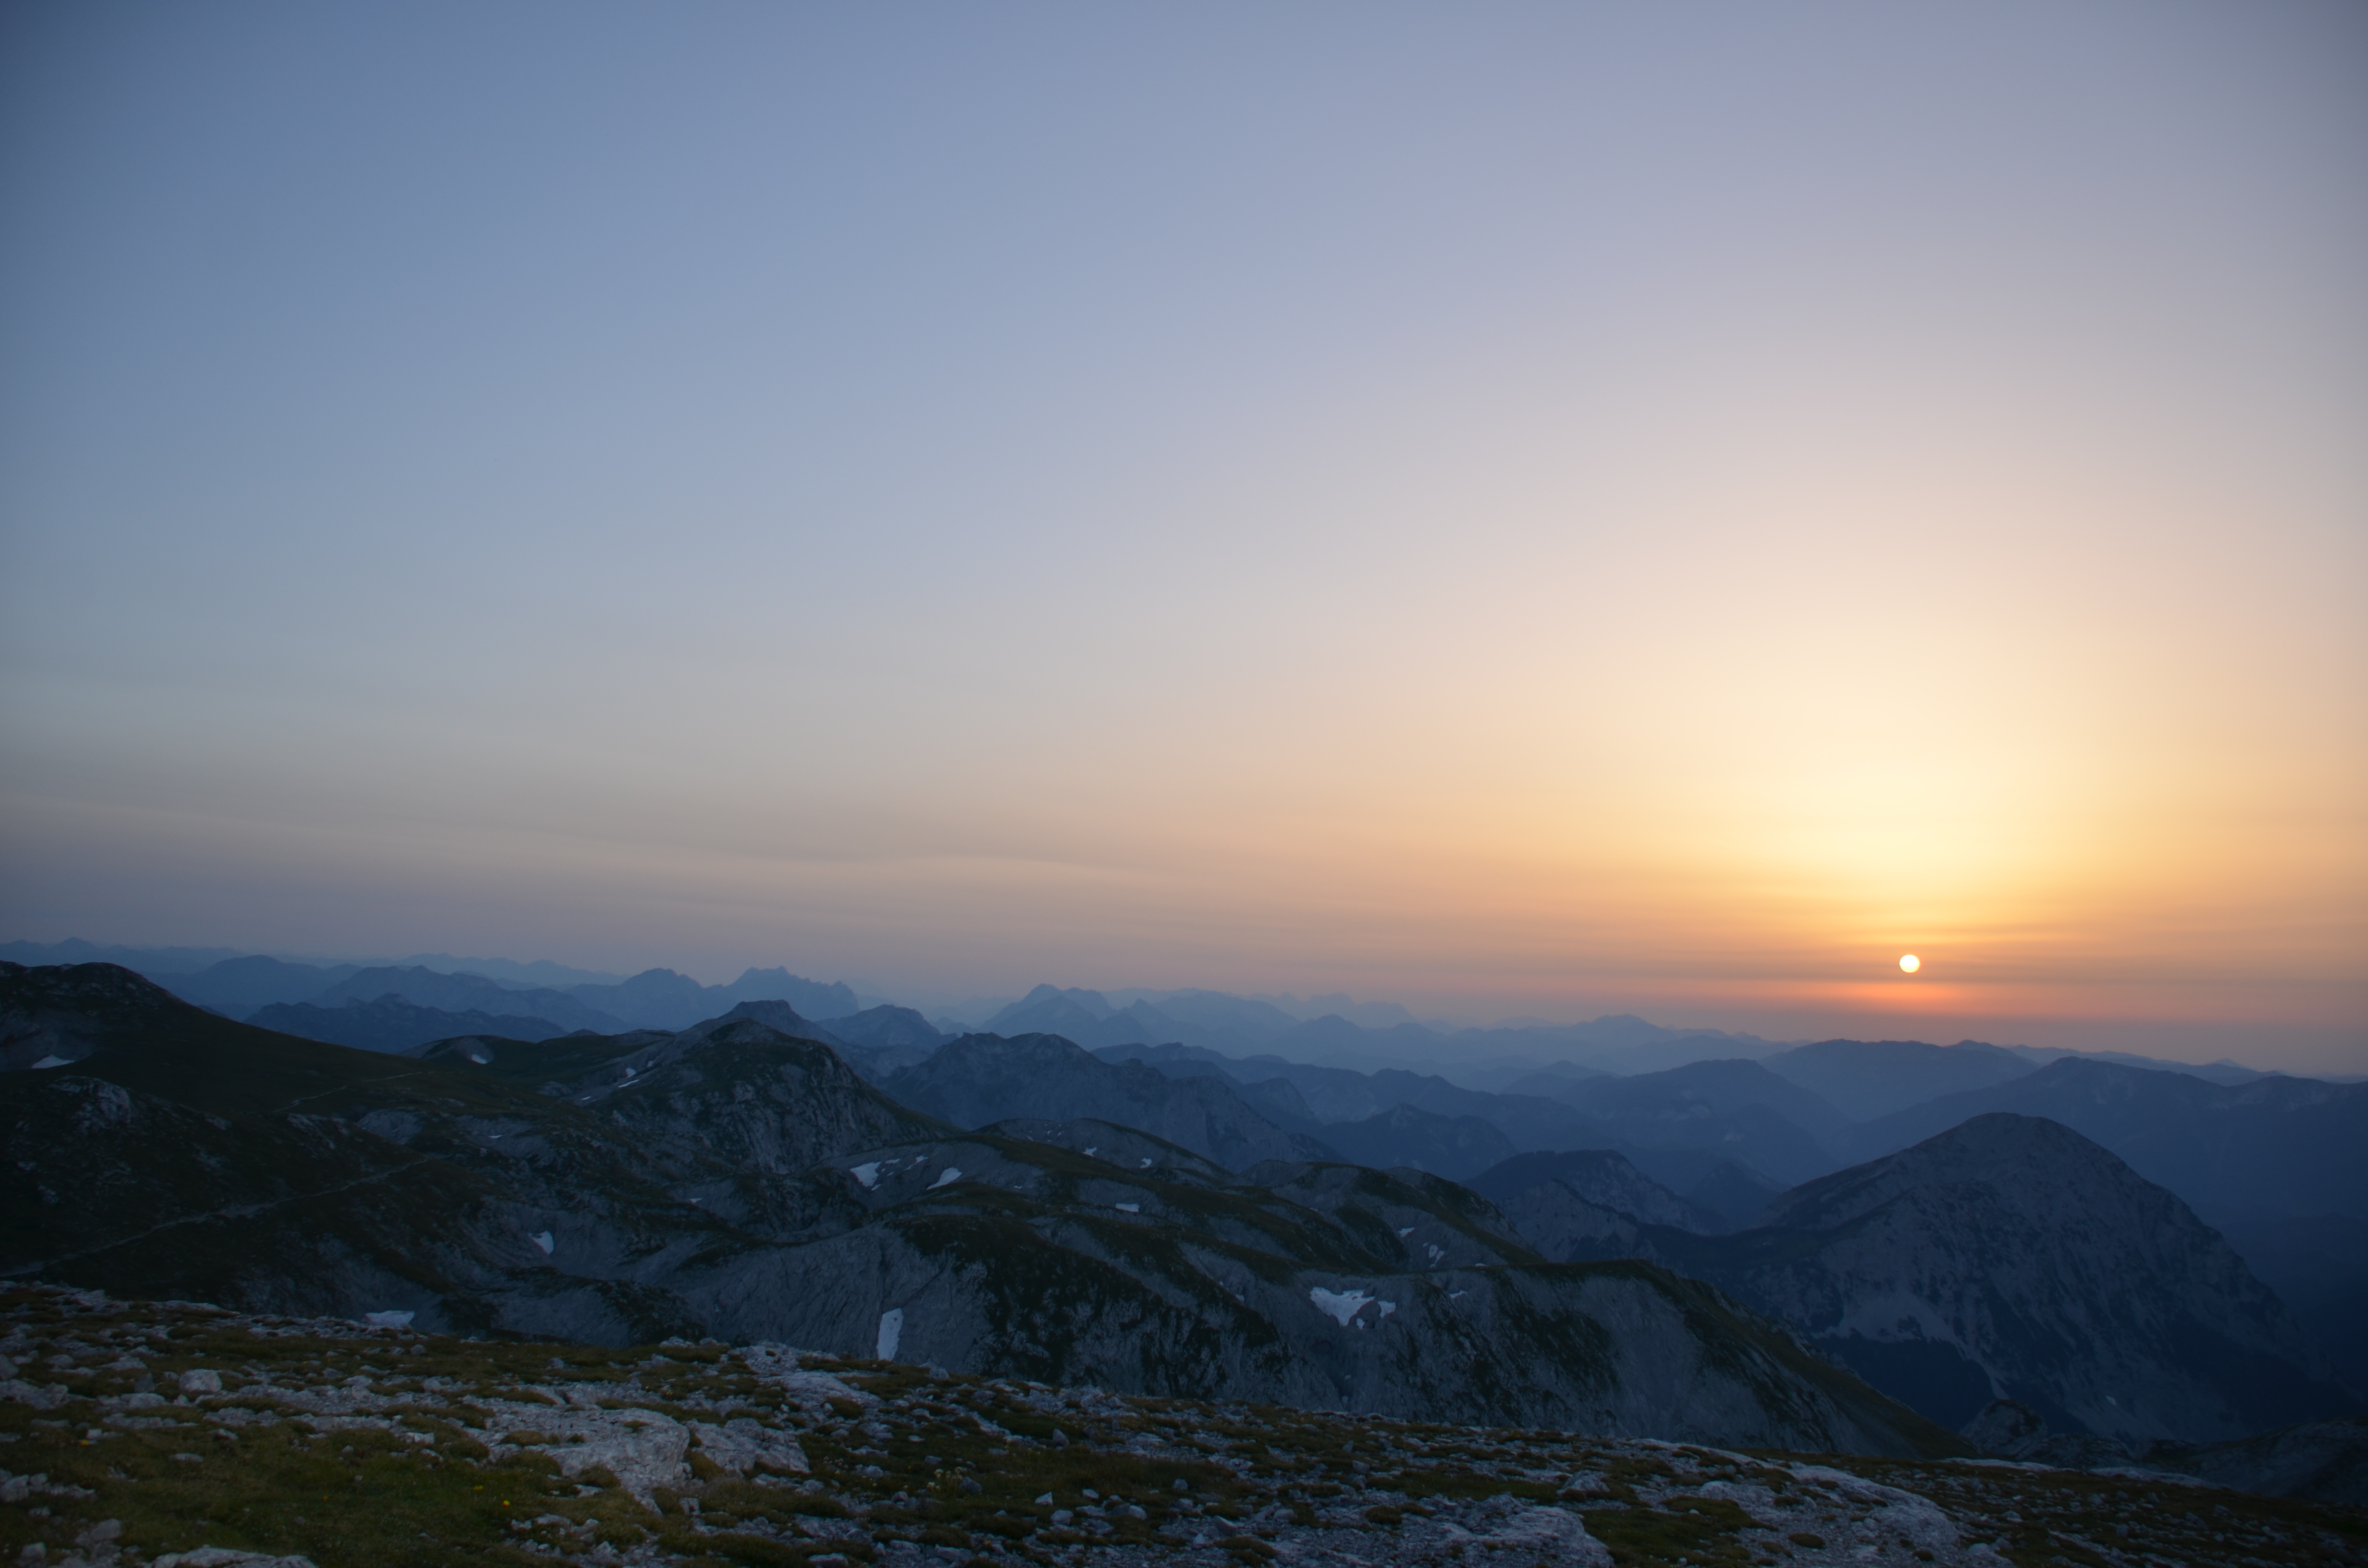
[0,0,2368,1073]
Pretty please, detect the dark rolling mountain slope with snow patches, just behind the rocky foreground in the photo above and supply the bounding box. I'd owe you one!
[0,967,1954,1452]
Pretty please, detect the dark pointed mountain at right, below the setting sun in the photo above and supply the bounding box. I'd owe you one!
[1563,1115,2354,1452]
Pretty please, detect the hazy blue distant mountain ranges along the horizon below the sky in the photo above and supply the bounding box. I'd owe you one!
[0,943,2368,1383]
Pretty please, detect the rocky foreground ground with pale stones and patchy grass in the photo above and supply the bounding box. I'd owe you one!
[0,1288,2368,1568]
